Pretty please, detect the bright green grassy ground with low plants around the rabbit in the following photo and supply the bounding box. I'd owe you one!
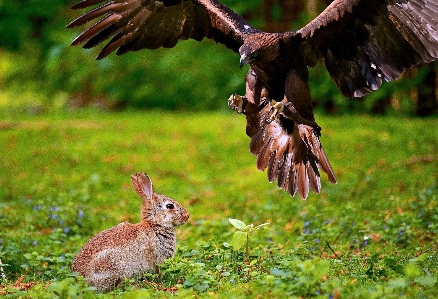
[0,111,438,298]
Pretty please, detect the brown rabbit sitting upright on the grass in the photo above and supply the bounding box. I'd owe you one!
[72,172,190,292]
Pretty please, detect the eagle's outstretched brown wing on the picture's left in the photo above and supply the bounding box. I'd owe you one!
[67,0,256,59]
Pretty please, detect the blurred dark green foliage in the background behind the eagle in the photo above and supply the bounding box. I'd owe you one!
[0,0,437,114]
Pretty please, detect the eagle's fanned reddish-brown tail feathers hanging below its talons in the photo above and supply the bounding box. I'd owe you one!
[247,109,336,199]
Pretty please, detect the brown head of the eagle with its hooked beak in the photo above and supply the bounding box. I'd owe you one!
[239,32,279,67]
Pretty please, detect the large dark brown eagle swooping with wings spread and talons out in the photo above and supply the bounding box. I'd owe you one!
[67,0,438,199]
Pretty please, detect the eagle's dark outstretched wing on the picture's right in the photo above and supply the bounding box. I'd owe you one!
[294,0,438,98]
